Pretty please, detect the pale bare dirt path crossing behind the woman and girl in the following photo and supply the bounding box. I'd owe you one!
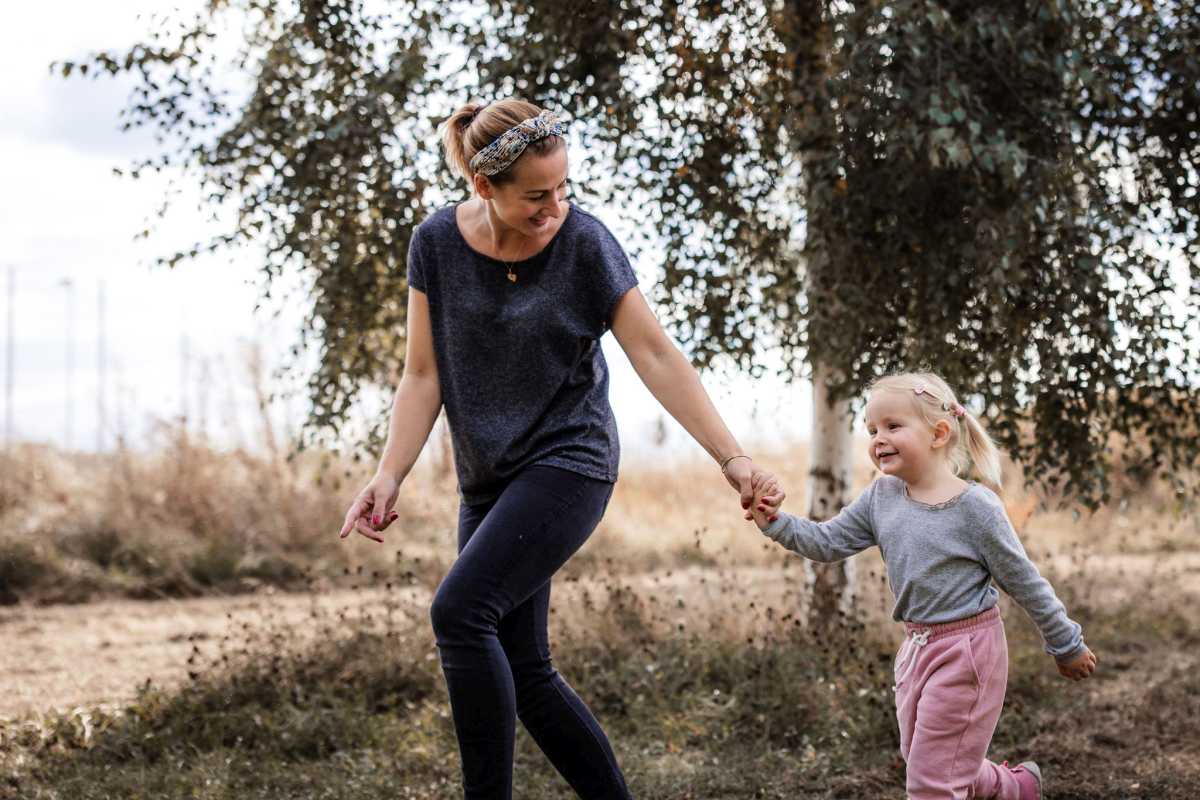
[0,552,1200,720]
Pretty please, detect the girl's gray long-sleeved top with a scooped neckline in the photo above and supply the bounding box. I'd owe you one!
[763,475,1085,663]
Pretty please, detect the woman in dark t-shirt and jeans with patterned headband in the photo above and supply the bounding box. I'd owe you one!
[341,100,756,799]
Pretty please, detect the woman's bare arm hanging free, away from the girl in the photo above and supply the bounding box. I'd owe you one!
[341,287,442,542]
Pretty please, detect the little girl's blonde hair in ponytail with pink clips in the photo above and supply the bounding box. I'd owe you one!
[866,372,1002,494]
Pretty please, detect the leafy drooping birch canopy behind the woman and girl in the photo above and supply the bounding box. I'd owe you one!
[52,0,1200,513]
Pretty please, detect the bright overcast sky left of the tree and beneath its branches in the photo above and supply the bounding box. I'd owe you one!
[0,0,810,458]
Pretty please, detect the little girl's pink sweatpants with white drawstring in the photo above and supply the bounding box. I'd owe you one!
[895,608,1020,800]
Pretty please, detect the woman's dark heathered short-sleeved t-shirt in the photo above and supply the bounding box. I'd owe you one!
[408,205,637,504]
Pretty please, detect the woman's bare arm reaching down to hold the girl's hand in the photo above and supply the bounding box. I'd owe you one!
[612,288,754,507]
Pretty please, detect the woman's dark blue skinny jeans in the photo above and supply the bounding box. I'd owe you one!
[431,467,630,800]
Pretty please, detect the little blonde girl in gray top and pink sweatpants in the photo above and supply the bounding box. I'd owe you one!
[748,373,1096,800]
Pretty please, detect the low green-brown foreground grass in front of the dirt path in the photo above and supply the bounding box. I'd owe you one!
[0,573,1200,800]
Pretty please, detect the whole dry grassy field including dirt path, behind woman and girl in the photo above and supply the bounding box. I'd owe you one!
[0,435,1200,800]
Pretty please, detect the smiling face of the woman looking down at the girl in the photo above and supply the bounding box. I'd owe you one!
[476,146,568,239]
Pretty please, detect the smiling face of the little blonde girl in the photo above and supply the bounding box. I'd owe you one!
[866,391,949,483]
